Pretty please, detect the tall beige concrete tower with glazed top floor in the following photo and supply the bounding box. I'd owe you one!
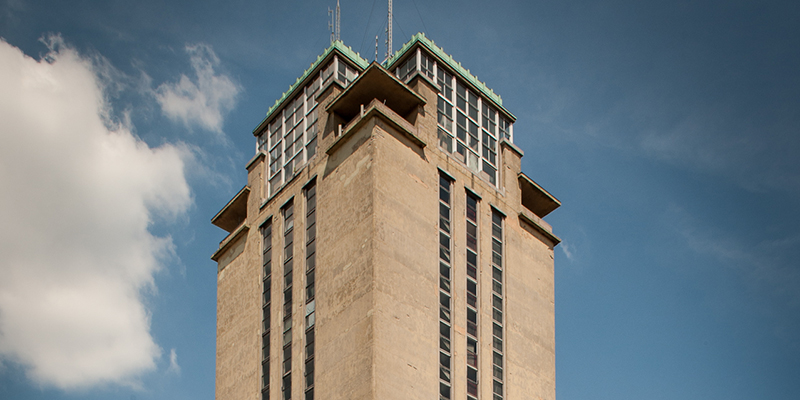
[212,34,560,400]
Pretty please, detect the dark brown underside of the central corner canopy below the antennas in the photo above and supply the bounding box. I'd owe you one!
[327,62,425,121]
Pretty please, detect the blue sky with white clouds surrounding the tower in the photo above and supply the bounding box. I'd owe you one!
[0,0,800,400]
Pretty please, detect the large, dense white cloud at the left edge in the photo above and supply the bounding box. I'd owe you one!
[0,37,191,389]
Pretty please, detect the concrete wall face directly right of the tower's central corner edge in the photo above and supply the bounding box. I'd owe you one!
[374,121,439,400]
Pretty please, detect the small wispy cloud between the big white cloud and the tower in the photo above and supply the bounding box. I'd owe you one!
[156,44,240,133]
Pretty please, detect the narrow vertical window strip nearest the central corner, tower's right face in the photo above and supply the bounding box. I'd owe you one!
[439,174,453,400]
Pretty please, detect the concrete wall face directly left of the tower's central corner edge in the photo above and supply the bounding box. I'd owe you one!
[315,117,375,400]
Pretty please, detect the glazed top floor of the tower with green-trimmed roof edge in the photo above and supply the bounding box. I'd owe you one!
[253,33,515,196]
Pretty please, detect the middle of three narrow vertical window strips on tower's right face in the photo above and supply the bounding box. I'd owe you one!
[467,193,478,400]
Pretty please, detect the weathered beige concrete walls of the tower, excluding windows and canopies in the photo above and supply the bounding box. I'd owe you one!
[216,61,555,400]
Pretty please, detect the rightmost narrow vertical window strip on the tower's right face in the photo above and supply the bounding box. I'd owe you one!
[492,210,504,400]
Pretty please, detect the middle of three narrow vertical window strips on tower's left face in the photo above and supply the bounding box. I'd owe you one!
[281,203,294,400]
